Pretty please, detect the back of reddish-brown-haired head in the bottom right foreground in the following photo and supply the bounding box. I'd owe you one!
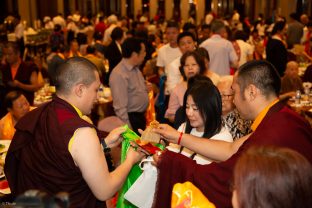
[232,147,312,208]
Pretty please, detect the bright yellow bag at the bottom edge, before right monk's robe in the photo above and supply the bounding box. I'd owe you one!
[171,181,216,208]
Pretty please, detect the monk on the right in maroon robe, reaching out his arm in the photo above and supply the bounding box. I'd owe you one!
[154,61,312,207]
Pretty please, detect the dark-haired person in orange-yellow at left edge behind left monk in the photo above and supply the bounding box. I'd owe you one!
[0,91,31,140]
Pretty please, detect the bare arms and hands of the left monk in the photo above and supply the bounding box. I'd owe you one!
[70,128,143,201]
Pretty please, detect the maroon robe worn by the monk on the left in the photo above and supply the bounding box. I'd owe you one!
[5,97,105,207]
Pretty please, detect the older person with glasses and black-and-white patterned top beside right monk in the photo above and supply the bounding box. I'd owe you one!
[217,75,252,140]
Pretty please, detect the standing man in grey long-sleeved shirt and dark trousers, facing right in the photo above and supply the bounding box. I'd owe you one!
[109,38,149,132]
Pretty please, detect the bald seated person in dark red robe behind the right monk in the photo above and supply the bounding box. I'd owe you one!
[281,61,303,96]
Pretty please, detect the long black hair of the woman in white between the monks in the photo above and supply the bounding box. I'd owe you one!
[183,75,222,138]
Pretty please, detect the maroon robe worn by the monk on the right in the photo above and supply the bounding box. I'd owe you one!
[153,102,312,208]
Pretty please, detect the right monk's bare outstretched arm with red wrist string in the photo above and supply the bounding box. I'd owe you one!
[154,124,250,161]
